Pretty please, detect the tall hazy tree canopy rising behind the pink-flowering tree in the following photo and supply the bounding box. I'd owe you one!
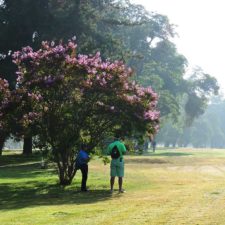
[0,0,218,153]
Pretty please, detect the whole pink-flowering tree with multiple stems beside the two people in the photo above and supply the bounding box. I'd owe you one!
[13,40,159,185]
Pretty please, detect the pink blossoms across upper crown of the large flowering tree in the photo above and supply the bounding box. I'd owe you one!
[13,40,160,135]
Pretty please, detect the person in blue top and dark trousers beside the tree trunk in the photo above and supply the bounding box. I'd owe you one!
[75,144,90,191]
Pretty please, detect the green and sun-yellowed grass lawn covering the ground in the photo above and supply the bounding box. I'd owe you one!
[0,149,225,225]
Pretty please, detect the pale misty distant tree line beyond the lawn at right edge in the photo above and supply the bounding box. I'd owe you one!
[157,97,225,148]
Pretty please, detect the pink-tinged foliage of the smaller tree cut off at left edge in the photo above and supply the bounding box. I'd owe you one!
[0,79,36,155]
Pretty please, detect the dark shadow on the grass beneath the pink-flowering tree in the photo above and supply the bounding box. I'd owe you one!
[0,181,116,211]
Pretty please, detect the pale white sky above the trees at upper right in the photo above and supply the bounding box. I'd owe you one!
[130,0,225,94]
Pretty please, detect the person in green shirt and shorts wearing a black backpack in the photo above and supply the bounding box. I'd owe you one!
[107,137,126,193]
